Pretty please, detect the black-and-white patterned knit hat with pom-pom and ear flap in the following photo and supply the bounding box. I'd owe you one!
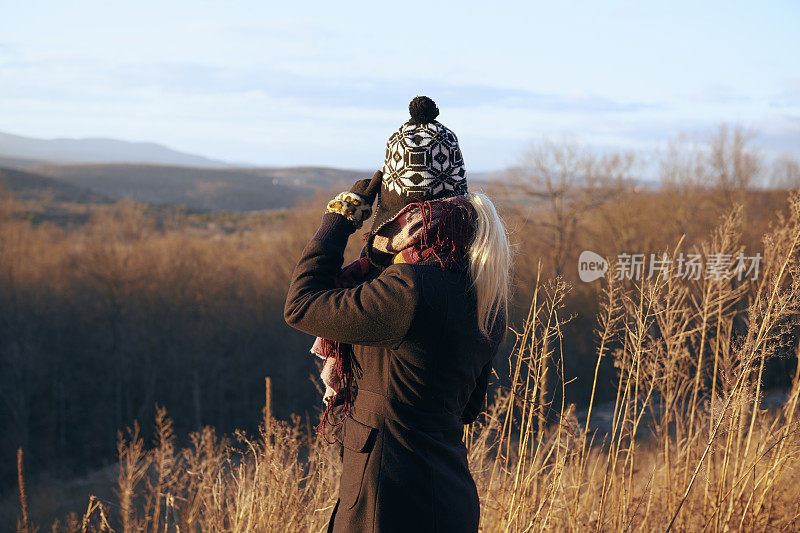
[366,96,467,264]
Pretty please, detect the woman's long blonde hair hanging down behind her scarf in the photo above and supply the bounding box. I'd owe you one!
[467,192,511,337]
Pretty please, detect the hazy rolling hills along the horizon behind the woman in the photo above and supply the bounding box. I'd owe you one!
[0,129,490,212]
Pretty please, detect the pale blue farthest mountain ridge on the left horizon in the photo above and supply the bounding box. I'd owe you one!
[0,133,229,168]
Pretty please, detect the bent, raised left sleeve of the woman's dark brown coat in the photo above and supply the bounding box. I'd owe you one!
[283,213,419,348]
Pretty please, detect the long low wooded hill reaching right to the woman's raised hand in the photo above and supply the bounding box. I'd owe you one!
[29,163,364,211]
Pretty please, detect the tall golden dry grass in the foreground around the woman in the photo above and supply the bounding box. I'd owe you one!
[15,190,800,532]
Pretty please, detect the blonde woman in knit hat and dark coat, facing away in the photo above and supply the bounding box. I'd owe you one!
[284,97,510,532]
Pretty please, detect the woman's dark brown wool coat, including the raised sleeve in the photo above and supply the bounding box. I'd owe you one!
[284,213,505,533]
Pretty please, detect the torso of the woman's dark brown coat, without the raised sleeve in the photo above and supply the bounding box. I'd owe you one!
[318,264,504,532]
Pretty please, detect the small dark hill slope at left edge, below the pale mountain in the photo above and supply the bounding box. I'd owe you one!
[0,168,109,203]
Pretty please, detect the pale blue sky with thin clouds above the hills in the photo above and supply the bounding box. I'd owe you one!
[0,0,800,171]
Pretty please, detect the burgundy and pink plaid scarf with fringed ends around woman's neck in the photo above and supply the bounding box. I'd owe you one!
[311,195,476,438]
